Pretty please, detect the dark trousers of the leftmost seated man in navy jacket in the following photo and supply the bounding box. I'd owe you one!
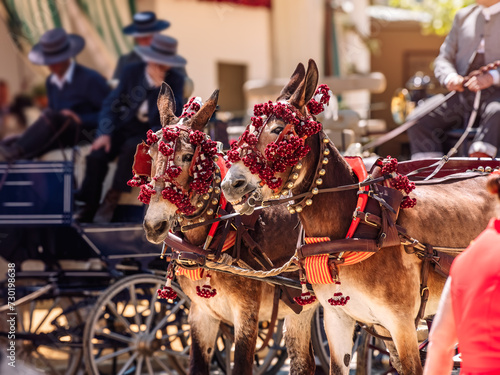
[3,109,85,159]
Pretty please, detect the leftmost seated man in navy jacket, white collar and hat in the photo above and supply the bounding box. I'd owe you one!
[0,28,110,162]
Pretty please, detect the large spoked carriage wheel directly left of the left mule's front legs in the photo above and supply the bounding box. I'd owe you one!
[83,274,190,375]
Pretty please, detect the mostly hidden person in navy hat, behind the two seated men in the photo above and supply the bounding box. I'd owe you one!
[113,12,170,79]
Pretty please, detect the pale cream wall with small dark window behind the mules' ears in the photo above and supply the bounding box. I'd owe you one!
[152,0,271,99]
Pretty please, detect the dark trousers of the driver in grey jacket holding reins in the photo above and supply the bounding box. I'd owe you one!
[408,87,500,155]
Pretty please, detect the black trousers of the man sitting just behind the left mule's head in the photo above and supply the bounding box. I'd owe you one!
[77,124,149,207]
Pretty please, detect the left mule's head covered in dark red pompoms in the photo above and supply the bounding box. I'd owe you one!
[143,83,219,243]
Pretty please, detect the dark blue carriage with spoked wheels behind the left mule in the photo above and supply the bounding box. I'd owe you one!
[0,161,287,375]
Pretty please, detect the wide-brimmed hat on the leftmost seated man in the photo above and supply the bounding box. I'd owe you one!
[28,28,85,65]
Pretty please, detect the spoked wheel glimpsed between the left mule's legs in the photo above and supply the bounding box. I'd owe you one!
[214,320,288,375]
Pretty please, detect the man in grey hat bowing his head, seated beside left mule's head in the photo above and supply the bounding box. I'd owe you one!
[75,34,186,222]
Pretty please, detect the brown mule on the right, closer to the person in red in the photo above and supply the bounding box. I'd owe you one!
[222,60,493,375]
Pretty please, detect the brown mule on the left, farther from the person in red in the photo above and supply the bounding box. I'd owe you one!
[144,85,317,374]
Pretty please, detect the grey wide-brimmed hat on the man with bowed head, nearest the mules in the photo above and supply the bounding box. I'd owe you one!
[135,34,187,68]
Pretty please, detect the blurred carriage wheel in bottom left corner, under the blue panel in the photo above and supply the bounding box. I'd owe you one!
[10,292,84,375]
